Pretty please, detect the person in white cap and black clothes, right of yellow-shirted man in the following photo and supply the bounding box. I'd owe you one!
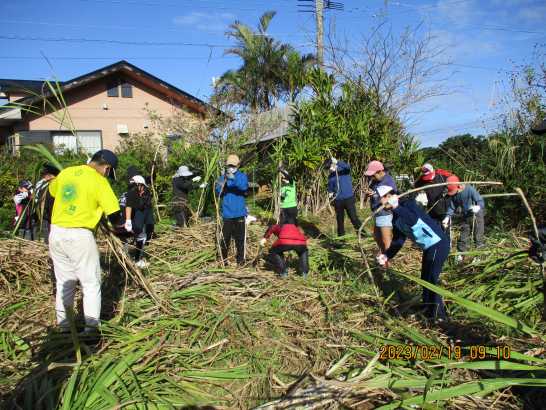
[124,175,155,268]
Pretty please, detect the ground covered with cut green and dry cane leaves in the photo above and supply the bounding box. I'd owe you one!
[0,216,546,409]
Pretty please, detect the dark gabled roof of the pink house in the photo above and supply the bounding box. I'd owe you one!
[0,60,225,115]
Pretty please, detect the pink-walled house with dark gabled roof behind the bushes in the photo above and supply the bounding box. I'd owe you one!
[0,61,222,153]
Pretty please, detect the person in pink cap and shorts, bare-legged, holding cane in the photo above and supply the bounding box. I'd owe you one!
[364,161,398,253]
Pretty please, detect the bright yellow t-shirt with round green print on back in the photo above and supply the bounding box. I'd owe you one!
[49,165,119,229]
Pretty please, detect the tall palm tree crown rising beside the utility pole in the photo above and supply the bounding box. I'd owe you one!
[213,11,314,112]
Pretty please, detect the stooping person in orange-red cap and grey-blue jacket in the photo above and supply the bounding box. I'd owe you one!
[442,175,485,263]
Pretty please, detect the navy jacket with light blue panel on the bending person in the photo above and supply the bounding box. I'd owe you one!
[385,199,449,259]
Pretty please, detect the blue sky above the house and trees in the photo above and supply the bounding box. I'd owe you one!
[0,0,546,146]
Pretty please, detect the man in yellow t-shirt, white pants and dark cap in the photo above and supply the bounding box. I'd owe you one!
[49,150,121,331]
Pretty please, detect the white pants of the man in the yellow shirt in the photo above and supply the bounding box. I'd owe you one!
[49,224,101,328]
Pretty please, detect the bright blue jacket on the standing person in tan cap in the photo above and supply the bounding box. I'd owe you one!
[215,171,248,219]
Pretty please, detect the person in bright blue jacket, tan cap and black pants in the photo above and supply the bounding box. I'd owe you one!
[215,154,248,265]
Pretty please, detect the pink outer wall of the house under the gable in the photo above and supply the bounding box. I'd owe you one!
[15,75,202,149]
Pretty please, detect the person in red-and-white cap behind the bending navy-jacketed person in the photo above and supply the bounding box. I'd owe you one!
[415,163,453,233]
